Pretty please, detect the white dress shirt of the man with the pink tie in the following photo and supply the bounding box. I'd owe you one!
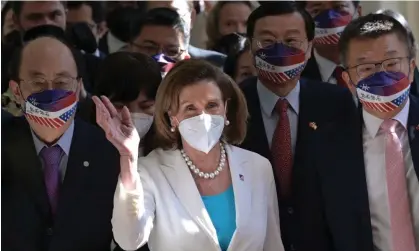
[363,100,419,251]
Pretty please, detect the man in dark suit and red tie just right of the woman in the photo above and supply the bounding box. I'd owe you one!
[241,1,372,251]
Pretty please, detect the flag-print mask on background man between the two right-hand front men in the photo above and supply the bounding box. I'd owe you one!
[313,10,352,45]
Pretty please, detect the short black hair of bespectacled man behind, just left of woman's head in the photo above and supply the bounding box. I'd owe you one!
[131,8,189,42]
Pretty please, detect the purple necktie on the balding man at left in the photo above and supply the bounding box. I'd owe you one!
[40,145,62,215]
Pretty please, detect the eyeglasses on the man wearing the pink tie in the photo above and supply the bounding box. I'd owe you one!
[346,57,410,79]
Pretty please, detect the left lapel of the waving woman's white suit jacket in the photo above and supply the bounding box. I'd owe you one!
[159,150,218,245]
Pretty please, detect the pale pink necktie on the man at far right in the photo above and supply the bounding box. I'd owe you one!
[381,119,416,251]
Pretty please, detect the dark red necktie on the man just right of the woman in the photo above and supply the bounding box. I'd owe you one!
[271,99,292,198]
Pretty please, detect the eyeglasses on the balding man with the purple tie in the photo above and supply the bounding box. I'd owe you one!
[19,76,81,92]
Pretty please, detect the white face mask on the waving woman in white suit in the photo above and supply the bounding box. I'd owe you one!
[179,113,224,153]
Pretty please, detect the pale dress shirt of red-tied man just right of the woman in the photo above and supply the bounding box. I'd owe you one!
[256,80,300,154]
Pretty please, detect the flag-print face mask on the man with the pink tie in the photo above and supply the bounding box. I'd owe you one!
[356,71,410,112]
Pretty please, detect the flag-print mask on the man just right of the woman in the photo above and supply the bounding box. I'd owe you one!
[255,43,306,84]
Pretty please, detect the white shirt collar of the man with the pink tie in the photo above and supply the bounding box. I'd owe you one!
[362,99,410,138]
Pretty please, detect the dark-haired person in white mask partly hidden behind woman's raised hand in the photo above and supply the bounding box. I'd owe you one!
[91,51,162,155]
